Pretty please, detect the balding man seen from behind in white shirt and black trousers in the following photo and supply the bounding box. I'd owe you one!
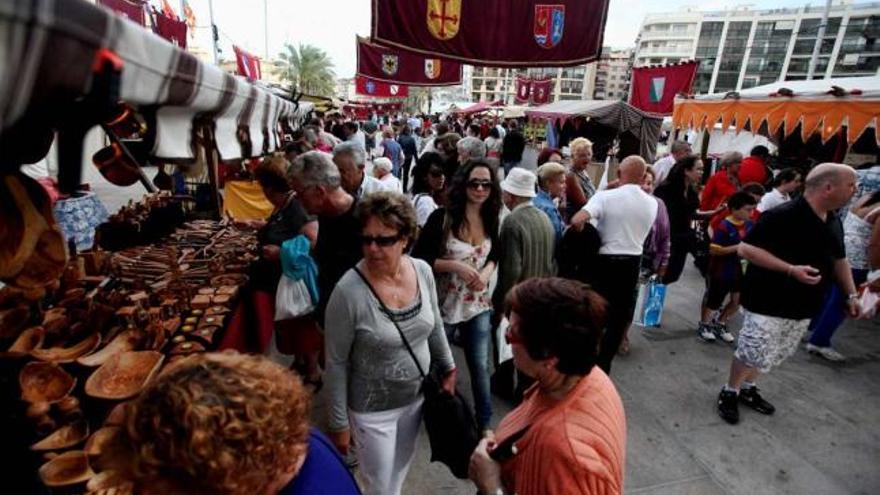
[571,155,657,373]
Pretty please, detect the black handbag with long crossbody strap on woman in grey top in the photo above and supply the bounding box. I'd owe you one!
[354,267,480,479]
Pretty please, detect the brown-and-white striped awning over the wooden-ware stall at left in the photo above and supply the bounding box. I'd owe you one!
[0,0,311,165]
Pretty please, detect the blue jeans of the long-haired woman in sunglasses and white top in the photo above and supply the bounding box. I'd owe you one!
[445,311,492,430]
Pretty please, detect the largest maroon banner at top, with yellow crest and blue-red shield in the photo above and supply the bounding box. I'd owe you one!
[372,0,609,67]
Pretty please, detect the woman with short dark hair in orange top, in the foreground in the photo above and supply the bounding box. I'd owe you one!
[470,278,626,495]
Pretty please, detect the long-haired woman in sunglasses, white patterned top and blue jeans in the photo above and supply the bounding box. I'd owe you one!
[413,161,501,430]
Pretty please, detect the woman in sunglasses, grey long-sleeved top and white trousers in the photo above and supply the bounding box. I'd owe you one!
[325,192,455,495]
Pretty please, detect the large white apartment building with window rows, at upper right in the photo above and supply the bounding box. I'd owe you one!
[634,0,880,93]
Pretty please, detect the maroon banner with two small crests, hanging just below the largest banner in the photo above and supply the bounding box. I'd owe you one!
[357,37,461,86]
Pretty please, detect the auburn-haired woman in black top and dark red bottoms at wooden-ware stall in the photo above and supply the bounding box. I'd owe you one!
[236,156,320,360]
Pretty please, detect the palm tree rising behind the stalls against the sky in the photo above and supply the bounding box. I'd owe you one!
[279,43,336,96]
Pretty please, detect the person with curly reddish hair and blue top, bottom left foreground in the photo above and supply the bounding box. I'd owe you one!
[101,353,360,495]
